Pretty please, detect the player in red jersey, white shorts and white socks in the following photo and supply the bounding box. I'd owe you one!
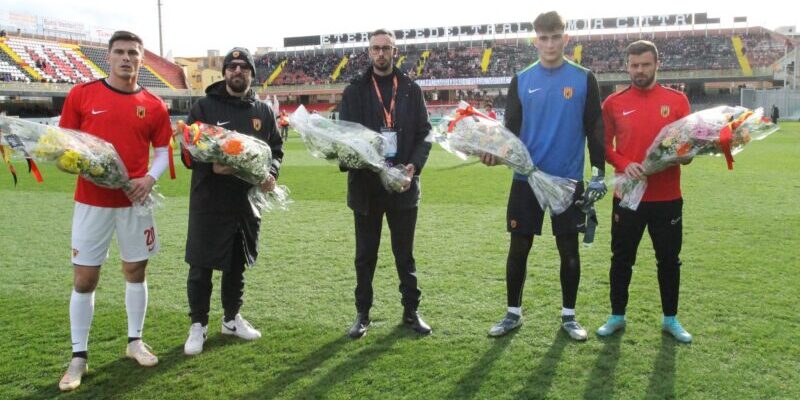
[59,31,172,391]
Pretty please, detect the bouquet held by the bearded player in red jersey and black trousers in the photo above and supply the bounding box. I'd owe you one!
[615,106,778,210]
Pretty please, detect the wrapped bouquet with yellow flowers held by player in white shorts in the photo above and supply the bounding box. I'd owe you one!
[0,116,163,215]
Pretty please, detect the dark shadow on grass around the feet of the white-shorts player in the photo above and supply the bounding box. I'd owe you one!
[22,336,203,400]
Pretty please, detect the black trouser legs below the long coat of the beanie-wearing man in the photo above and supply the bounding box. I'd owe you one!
[186,264,244,325]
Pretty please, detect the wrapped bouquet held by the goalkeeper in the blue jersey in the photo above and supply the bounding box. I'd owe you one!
[433,101,577,215]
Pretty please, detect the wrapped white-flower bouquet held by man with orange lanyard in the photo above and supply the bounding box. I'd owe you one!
[289,106,411,192]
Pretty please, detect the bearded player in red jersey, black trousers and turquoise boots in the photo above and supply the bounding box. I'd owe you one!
[597,40,692,343]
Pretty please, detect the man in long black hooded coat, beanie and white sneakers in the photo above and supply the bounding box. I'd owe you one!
[184,47,283,355]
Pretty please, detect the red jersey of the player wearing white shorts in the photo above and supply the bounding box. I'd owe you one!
[59,80,172,208]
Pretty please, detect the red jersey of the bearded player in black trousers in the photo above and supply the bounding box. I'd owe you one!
[603,85,691,201]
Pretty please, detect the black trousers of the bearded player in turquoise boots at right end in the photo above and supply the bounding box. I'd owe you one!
[609,198,683,317]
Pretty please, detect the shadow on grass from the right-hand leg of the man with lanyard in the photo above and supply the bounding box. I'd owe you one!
[288,324,406,399]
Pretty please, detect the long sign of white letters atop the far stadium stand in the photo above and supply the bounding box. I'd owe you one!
[283,13,720,47]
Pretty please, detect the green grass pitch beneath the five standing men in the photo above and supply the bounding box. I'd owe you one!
[0,123,800,399]
